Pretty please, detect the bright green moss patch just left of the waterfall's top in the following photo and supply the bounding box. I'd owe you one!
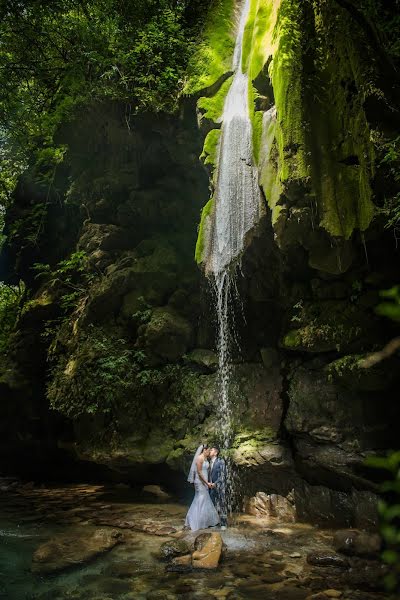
[183,0,236,94]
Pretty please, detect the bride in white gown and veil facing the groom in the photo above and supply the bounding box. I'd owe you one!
[185,444,219,531]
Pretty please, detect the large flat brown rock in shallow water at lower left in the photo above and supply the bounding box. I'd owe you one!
[31,529,122,575]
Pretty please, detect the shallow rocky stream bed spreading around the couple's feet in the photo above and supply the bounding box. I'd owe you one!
[0,481,394,600]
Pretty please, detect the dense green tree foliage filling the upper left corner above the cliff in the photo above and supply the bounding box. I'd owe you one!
[0,0,214,211]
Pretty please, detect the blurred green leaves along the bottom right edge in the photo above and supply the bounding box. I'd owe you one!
[366,450,400,591]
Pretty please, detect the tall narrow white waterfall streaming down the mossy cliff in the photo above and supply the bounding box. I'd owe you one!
[206,0,261,506]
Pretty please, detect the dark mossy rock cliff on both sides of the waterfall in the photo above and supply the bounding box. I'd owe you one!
[0,0,400,528]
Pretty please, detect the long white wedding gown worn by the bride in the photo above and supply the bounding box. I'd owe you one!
[185,460,219,531]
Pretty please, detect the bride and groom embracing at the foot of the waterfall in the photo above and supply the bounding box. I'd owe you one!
[185,444,226,531]
